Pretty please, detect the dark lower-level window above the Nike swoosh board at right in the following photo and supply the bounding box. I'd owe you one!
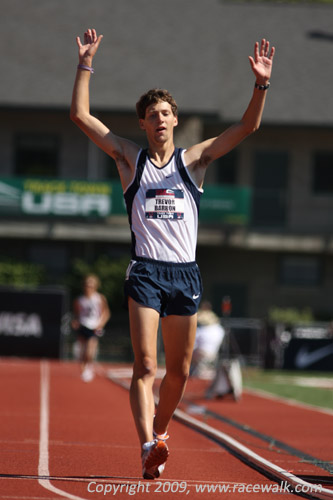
[279,255,322,287]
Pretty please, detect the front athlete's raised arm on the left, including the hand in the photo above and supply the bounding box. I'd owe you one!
[70,29,140,189]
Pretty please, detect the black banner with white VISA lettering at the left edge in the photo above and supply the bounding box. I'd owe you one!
[0,288,68,358]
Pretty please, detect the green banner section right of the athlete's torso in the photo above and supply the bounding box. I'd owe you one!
[200,185,251,225]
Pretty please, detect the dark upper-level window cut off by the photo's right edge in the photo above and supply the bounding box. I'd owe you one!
[313,151,333,194]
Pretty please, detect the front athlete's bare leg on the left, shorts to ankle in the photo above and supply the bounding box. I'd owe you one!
[128,298,159,445]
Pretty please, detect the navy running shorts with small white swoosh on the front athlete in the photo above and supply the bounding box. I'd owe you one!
[124,257,202,318]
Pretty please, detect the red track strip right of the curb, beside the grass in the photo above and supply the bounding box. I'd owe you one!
[182,392,333,466]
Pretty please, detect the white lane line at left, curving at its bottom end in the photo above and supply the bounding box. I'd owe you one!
[38,361,85,500]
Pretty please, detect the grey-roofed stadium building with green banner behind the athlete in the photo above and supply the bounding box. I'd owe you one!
[0,0,333,320]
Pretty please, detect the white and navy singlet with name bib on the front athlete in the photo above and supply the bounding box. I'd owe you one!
[124,148,203,263]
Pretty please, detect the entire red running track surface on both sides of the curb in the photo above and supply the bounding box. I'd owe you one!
[0,359,332,500]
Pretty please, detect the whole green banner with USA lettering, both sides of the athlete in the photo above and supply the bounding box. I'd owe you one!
[0,177,251,224]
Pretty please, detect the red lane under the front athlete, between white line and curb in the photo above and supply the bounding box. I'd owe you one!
[46,364,280,500]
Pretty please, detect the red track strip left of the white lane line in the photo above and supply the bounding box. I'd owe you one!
[0,358,54,500]
